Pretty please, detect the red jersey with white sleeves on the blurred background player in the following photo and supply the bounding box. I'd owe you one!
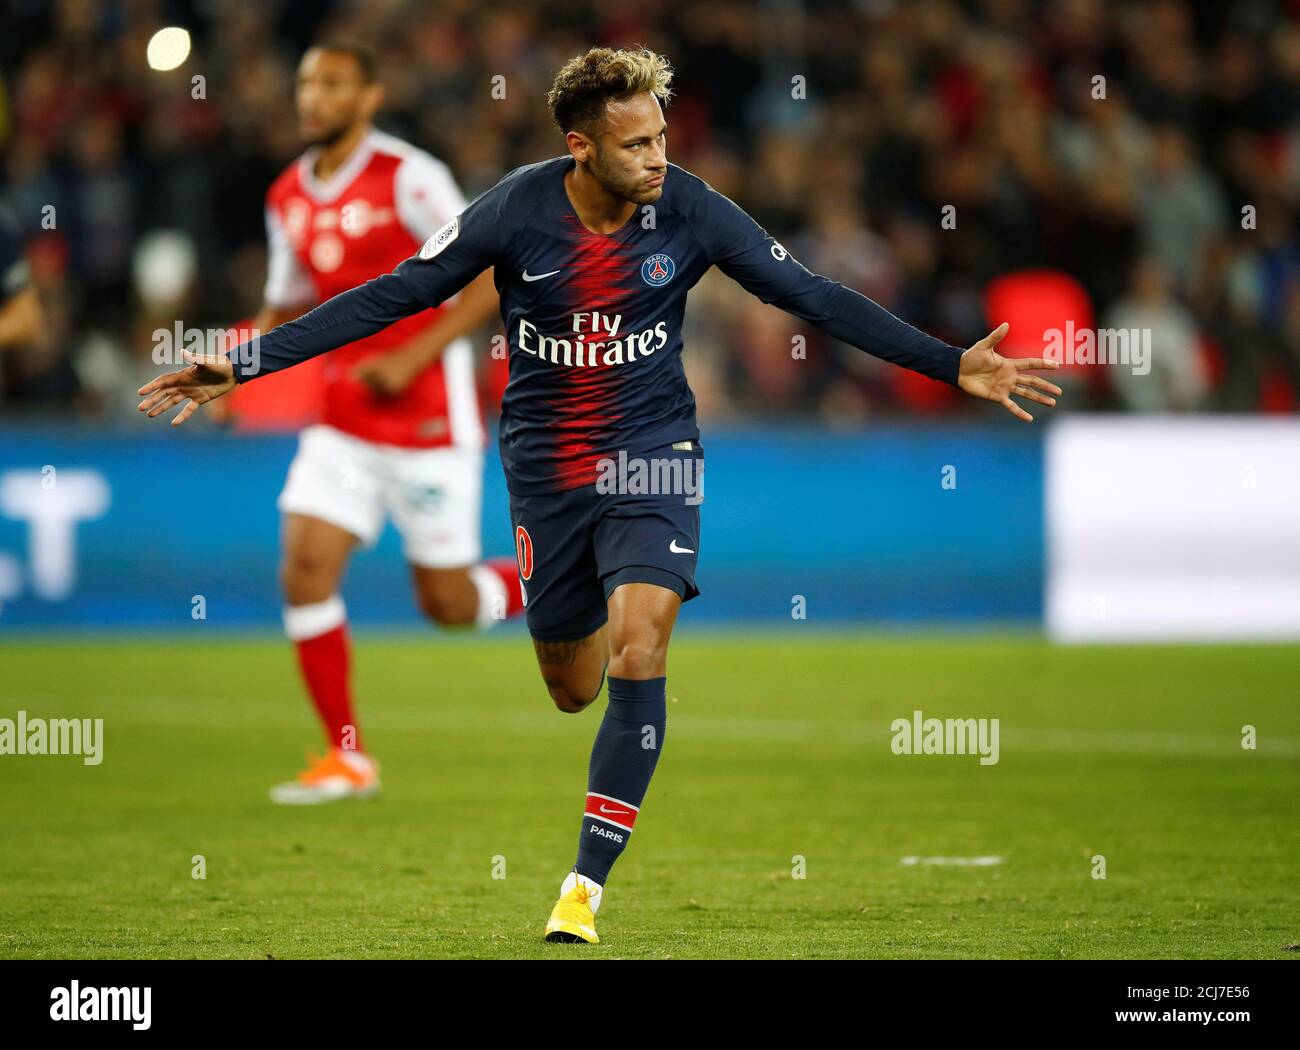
[265,130,484,448]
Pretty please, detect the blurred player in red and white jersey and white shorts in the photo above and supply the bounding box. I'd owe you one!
[255,42,523,804]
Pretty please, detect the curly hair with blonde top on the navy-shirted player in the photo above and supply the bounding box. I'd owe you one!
[546,47,672,133]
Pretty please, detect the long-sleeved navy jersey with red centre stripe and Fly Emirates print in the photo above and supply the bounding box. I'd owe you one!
[233,156,962,494]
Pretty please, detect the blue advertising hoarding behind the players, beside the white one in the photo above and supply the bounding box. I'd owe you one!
[0,425,1044,633]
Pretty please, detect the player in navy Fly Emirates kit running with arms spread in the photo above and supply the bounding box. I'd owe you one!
[140,48,1061,943]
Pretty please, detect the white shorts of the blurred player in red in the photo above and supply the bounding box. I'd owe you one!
[276,424,484,569]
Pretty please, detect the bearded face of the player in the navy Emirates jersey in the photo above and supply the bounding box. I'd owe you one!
[586,91,668,204]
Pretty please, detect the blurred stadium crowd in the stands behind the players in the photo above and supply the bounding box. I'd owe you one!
[0,0,1300,426]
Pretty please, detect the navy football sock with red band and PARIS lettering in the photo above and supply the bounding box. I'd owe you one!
[575,674,667,885]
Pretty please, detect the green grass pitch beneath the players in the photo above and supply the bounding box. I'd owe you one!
[0,628,1300,959]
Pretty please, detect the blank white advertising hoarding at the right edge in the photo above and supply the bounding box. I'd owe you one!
[1044,417,1300,642]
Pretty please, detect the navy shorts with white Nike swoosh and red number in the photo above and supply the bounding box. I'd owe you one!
[510,441,705,642]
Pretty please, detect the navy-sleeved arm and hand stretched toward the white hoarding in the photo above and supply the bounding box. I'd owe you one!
[692,188,1061,421]
